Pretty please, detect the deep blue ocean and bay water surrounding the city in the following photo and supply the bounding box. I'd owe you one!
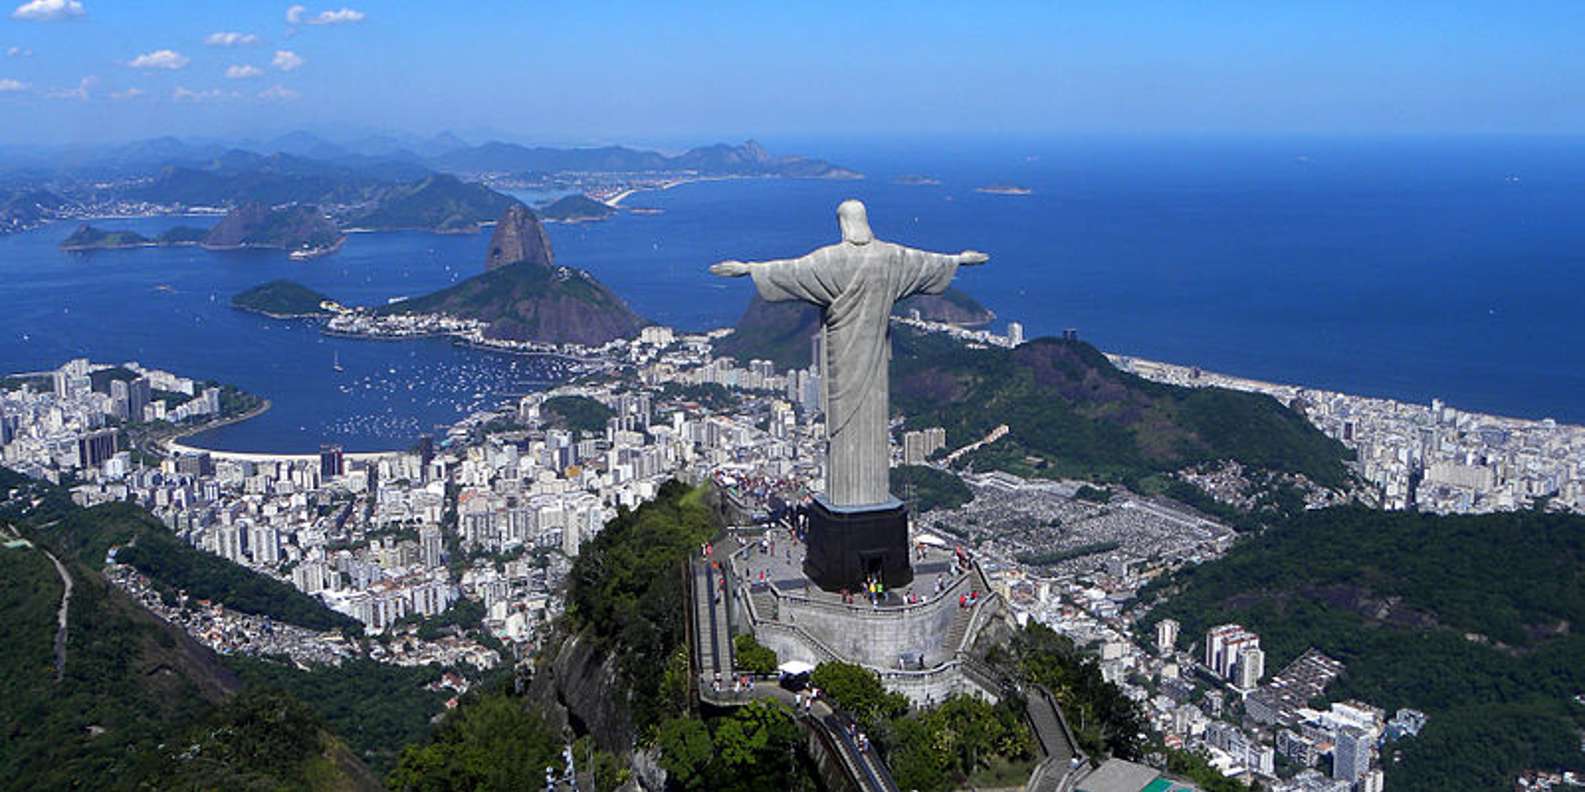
[0,138,1585,451]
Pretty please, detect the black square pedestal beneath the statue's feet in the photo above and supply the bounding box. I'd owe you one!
[804,496,913,592]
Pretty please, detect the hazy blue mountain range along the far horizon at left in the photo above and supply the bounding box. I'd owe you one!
[0,131,861,234]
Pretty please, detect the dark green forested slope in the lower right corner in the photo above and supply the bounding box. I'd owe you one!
[1141,508,1585,790]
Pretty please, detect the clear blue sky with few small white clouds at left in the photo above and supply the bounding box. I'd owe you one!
[0,0,1585,144]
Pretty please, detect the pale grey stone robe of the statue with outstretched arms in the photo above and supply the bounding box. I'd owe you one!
[750,241,957,507]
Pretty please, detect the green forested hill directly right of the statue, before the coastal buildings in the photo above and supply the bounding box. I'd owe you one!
[891,328,1349,486]
